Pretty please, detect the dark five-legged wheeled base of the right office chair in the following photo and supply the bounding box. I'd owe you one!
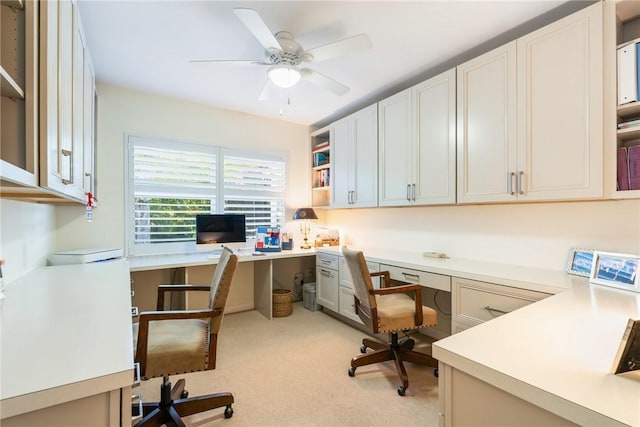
[349,332,438,396]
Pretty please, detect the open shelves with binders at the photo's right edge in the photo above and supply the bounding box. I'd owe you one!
[615,1,640,198]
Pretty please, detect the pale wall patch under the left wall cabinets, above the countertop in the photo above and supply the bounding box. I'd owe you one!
[0,199,55,284]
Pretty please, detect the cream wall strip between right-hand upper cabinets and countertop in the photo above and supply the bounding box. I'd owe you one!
[327,200,640,270]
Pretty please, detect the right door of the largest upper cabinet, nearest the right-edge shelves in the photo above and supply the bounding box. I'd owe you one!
[517,3,603,200]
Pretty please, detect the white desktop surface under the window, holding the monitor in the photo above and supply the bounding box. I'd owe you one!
[127,248,316,271]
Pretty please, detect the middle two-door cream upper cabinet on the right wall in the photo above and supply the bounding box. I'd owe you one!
[378,70,456,206]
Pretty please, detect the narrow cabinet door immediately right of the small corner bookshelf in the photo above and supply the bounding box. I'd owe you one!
[330,117,353,208]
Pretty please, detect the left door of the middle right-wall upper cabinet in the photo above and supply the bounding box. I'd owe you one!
[378,89,412,206]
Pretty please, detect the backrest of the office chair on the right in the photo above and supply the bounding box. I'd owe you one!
[342,246,378,331]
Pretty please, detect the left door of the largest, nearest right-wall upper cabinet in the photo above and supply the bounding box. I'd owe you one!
[457,41,517,203]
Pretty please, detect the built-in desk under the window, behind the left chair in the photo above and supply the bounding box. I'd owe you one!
[128,249,315,319]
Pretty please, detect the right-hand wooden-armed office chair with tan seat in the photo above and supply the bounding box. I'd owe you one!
[342,247,438,396]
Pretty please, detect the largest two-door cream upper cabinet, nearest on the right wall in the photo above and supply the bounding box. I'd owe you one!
[457,3,604,203]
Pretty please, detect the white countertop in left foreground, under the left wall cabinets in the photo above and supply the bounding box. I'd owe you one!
[0,260,133,419]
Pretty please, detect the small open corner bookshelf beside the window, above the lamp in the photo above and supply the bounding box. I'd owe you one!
[311,127,331,207]
